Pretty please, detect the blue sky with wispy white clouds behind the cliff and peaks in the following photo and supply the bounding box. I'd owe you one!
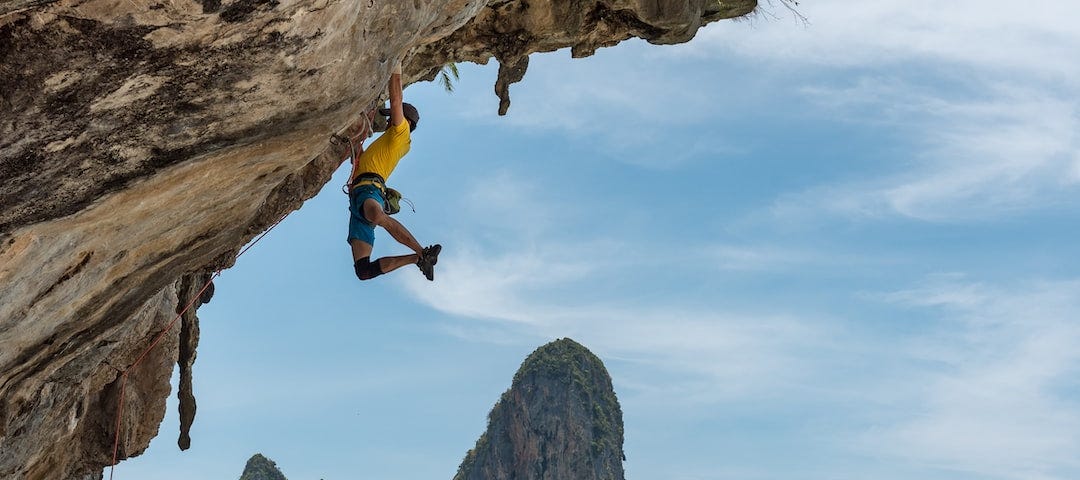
[116,0,1080,480]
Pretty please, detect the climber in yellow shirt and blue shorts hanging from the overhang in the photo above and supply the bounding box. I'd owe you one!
[348,62,443,280]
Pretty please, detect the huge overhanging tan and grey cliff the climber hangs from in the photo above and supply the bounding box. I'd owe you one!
[0,0,756,479]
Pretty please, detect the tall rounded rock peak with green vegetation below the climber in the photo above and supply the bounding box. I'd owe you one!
[454,338,624,480]
